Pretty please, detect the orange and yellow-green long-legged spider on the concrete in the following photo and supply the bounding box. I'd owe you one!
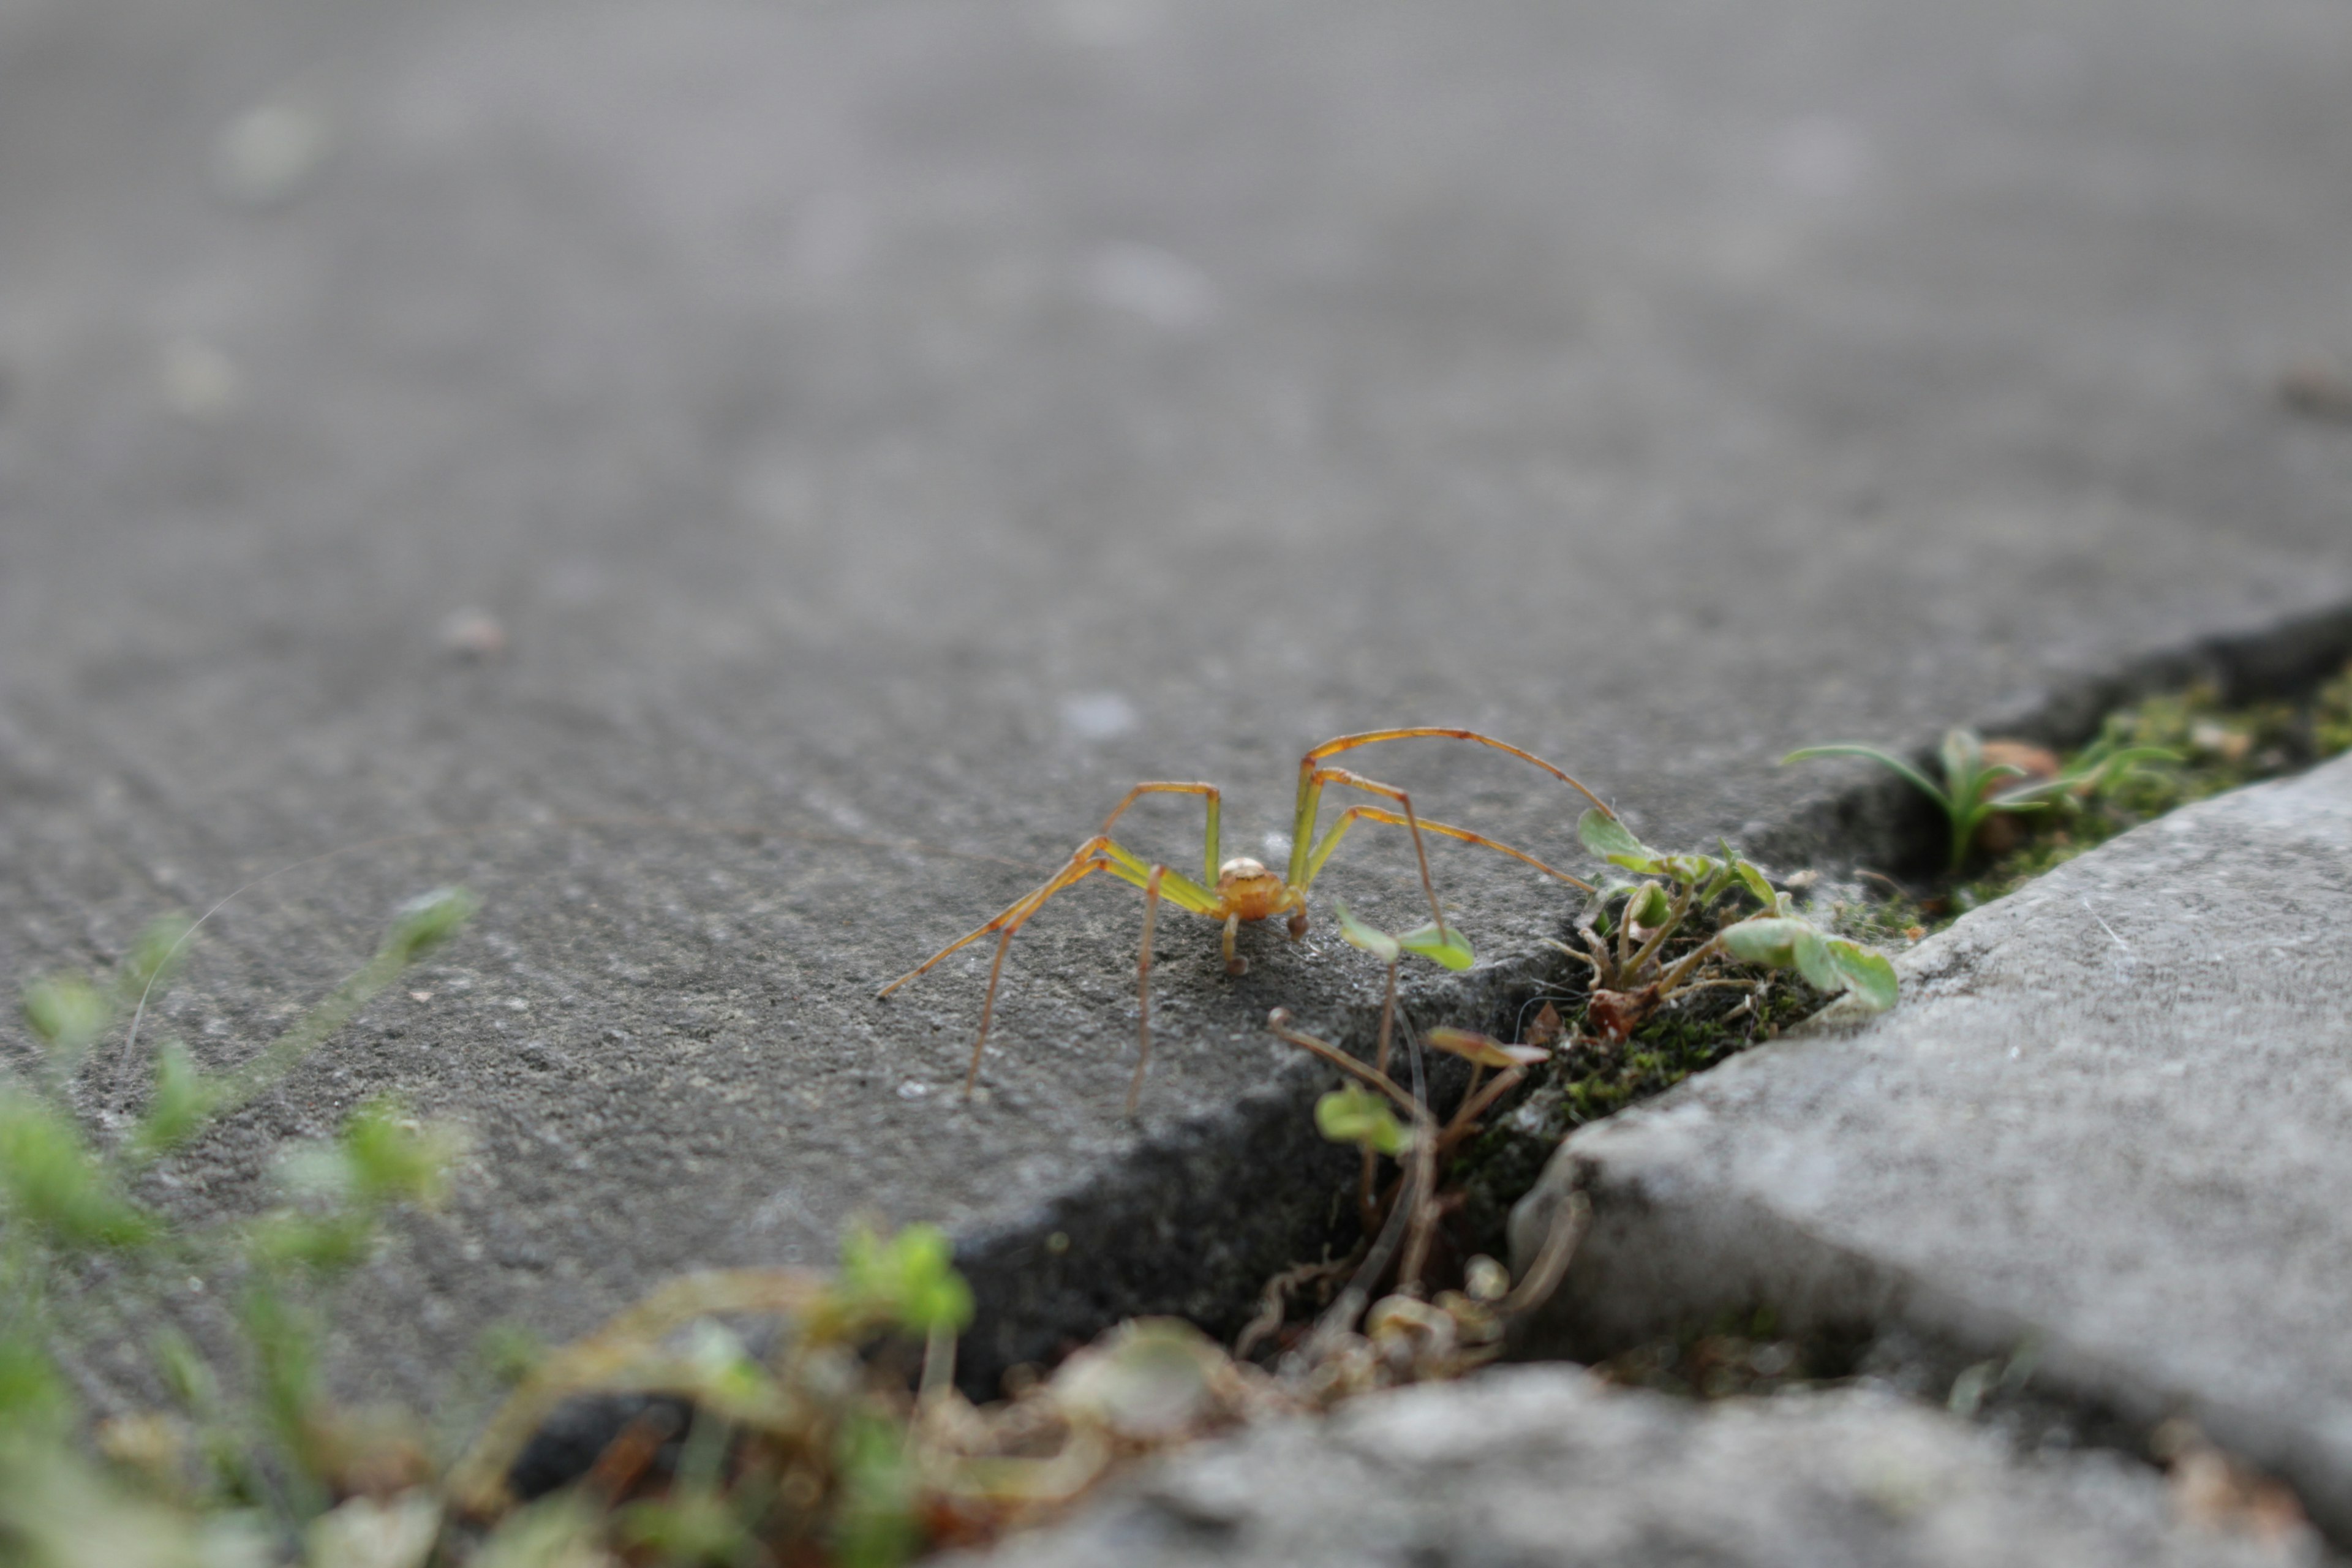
[875,729,1616,1117]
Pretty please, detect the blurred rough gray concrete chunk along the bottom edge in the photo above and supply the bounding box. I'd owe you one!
[943,1366,2319,1568]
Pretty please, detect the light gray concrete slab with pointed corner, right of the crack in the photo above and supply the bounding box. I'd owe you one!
[1521,760,2352,1537]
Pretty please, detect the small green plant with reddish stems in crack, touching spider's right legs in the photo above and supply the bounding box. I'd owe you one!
[1552,811,1896,1039]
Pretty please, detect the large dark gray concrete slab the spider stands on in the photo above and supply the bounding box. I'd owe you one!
[0,0,2352,1392]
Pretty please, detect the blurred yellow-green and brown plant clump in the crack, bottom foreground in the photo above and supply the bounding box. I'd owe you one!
[442,1227,1284,1568]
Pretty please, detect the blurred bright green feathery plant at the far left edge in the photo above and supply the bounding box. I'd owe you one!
[0,889,473,1568]
